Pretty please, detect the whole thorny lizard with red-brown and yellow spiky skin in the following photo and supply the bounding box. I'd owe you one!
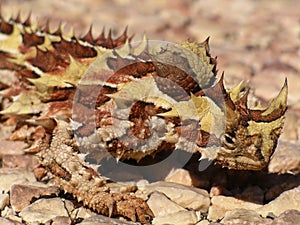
[0,13,287,223]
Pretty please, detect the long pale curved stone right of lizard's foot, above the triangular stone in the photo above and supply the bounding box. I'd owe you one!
[138,181,210,212]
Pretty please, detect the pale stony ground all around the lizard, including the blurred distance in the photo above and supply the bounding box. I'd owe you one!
[0,0,300,225]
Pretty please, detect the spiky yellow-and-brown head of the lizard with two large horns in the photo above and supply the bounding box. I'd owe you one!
[201,78,287,170]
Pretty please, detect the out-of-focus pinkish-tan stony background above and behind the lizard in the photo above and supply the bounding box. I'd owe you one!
[1,0,300,140]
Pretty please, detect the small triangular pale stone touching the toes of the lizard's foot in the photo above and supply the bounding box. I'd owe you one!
[147,192,186,217]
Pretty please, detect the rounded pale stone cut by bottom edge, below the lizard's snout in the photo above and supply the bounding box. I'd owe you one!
[221,209,272,225]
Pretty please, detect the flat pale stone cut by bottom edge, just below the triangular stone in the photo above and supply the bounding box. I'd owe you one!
[152,211,198,225]
